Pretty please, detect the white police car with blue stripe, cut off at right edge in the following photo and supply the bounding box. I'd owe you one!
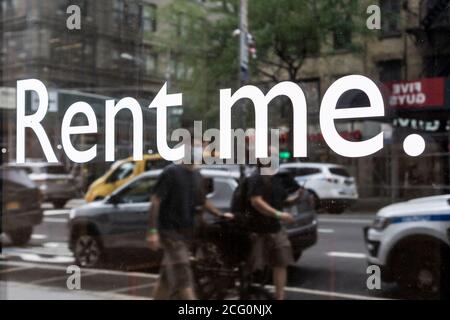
[364,194,450,294]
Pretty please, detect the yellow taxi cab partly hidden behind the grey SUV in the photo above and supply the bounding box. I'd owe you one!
[85,154,168,202]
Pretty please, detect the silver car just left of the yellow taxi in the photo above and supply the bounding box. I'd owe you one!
[9,161,80,208]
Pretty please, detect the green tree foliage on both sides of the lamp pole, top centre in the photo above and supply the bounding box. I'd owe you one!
[156,0,367,125]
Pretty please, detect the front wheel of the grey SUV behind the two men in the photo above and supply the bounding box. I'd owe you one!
[73,234,104,268]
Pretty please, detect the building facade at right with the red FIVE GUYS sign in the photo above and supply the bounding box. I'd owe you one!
[266,0,450,198]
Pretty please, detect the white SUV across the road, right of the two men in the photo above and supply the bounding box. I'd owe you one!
[280,162,358,213]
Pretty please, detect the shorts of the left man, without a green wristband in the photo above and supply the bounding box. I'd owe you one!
[160,232,194,294]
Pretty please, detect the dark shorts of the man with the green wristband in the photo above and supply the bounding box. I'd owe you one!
[249,230,294,270]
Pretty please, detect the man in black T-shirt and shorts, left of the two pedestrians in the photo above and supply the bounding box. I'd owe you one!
[147,141,232,300]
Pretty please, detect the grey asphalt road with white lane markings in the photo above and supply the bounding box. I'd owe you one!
[0,201,405,299]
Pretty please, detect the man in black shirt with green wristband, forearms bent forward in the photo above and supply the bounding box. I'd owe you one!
[247,151,301,300]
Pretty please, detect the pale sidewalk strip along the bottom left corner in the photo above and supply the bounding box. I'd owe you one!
[0,281,149,300]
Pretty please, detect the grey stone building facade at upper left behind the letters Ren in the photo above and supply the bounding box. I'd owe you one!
[0,0,174,180]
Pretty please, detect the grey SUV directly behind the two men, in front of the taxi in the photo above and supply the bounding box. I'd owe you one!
[69,169,317,267]
